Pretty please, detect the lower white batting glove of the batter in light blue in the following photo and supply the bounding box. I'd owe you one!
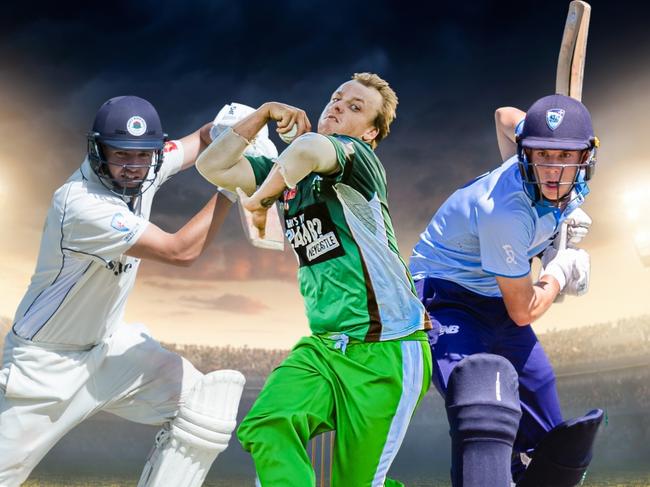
[540,247,591,296]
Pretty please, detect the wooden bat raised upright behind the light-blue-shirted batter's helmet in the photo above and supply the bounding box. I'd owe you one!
[553,0,591,302]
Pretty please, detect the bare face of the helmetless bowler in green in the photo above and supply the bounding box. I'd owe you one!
[318,80,382,142]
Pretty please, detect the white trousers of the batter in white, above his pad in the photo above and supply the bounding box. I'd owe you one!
[0,325,201,487]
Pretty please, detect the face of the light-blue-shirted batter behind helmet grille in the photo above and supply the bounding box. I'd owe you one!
[528,149,583,201]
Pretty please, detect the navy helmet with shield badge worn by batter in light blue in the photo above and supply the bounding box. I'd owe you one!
[516,94,599,206]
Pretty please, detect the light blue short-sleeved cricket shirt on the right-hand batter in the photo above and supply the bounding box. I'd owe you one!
[410,156,584,297]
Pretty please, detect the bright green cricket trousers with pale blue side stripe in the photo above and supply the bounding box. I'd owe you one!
[237,331,431,487]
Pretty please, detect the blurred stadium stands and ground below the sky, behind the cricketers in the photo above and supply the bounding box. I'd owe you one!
[2,315,650,487]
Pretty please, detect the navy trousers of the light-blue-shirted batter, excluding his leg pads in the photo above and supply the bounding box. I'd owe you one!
[415,278,562,452]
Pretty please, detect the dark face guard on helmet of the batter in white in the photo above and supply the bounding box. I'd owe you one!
[88,132,163,198]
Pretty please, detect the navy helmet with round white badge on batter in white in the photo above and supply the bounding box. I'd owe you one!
[88,96,167,197]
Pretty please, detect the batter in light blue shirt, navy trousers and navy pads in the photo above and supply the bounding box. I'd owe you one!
[410,95,600,487]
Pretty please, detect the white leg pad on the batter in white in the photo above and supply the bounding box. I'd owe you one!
[138,370,246,487]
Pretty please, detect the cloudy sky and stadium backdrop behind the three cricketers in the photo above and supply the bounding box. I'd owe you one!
[0,0,650,485]
